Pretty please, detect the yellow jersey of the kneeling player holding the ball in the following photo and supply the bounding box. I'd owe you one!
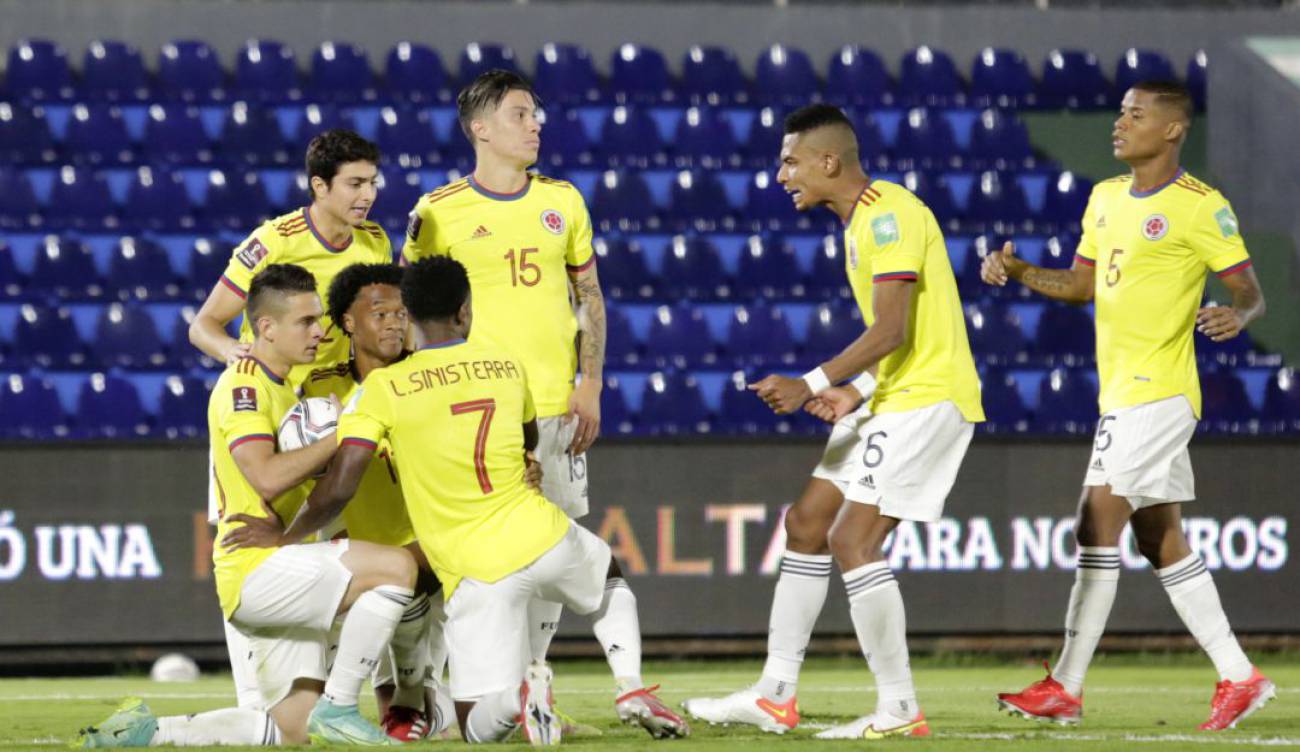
[208,358,308,619]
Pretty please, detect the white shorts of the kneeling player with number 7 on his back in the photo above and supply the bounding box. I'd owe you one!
[446,524,610,701]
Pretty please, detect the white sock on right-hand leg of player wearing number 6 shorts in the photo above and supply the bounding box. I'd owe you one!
[844,561,919,721]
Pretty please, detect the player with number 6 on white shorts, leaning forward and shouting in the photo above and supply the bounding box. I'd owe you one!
[686,104,984,739]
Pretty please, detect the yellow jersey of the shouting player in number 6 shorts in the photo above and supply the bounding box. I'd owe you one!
[844,180,984,423]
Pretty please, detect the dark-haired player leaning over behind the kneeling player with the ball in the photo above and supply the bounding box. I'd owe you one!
[190,130,393,386]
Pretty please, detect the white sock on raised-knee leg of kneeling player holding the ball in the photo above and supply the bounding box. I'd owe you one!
[325,585,415,705]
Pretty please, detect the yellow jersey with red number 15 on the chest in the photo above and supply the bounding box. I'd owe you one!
[402,174,595,418]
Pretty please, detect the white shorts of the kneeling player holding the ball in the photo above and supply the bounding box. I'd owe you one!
[230,540,352,710]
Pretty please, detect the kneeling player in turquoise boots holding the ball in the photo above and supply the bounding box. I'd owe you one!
[77,264,416,747]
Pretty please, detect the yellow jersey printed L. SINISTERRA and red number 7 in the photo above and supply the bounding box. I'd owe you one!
[338,340,569,598]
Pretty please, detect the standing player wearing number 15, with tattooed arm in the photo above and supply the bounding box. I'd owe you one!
[402,70,606,660]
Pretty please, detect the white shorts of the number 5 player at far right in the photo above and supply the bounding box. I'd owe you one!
[1083,396,1196,510]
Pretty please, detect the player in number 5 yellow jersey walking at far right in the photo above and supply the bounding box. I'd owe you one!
[980,81,1274,730]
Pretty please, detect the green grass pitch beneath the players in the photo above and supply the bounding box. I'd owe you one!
[0,656,1300,752]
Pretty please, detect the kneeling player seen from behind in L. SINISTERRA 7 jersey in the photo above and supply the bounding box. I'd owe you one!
[218,258,688,744]
